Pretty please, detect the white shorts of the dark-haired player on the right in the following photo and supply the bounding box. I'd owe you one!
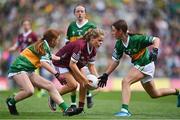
[134,62,155,84]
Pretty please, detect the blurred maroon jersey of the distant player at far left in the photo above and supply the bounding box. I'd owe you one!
[17,31,38,51]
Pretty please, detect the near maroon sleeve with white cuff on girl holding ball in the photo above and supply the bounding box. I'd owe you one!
[71,45,81,63]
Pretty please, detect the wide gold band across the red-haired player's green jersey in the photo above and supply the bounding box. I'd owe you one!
[21,48,41,68]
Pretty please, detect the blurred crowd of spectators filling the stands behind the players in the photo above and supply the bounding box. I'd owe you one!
[0,0,180,78]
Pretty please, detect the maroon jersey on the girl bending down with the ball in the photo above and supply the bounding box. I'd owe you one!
[53,39,96,68]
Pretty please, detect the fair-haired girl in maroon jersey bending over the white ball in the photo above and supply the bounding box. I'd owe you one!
[50,29,104,114]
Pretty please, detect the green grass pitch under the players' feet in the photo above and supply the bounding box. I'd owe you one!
[0,91,180,120]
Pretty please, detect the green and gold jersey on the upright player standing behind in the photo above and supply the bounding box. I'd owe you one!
[67,21,96,42]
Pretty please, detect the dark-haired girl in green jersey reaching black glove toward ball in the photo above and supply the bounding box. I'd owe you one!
[98,19,180,117]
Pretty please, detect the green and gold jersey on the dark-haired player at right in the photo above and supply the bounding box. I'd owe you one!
[112,34,154,66]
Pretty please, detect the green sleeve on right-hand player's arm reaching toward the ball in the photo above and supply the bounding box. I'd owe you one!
[112,41,123,62]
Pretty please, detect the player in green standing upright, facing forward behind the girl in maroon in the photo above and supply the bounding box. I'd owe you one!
[49,4,96,111]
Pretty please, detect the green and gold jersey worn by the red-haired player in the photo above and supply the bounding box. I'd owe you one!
[9,40,51,73]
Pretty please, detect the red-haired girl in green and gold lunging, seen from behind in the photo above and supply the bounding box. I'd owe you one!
[6,29,76,115]
